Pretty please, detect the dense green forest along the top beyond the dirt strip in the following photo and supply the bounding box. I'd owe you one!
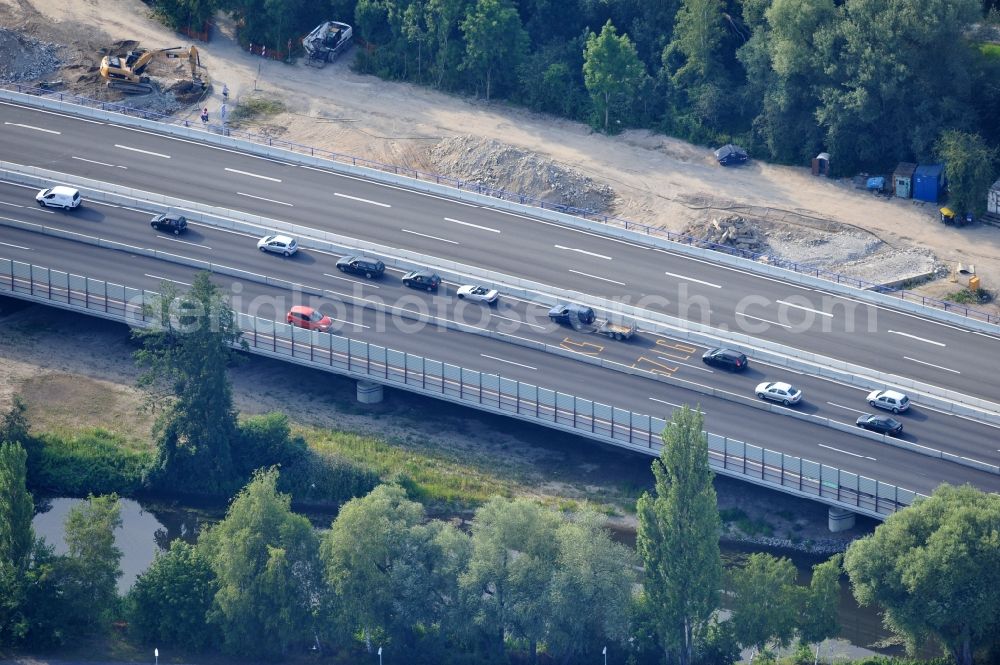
[155,0,1000,208]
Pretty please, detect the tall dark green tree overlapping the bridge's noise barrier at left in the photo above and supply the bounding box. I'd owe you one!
[133,272,247,493]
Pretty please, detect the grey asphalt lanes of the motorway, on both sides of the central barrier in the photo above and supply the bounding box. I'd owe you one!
[0,97,1000,492]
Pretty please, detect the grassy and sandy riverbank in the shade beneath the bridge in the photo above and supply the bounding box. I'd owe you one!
[0,299,876,554]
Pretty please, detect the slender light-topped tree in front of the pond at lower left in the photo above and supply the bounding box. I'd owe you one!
[65,494,122,625]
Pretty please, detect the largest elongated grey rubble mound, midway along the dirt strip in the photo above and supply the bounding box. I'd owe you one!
[431,136,615,212]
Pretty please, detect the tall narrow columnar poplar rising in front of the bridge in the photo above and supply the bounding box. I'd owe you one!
[636,407,722,665]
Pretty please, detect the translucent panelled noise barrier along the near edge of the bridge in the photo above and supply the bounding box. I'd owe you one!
[0,258,920,519]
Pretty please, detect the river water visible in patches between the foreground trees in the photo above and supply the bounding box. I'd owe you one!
[32,498,897,653]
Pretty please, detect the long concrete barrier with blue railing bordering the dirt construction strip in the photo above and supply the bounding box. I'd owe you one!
[0,83,1000,324]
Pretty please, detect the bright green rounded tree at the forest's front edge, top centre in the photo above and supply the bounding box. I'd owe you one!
[461,0,528,102]
